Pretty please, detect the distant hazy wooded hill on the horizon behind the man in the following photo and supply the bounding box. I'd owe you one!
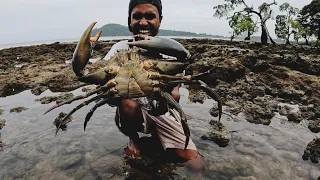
[92,24,223,38]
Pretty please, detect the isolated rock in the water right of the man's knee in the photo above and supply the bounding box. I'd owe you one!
[201,120,230,147]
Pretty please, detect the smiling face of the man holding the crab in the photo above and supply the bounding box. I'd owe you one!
[130,4,162,36]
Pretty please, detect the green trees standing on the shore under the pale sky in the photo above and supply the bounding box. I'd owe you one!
[213,0,320,44]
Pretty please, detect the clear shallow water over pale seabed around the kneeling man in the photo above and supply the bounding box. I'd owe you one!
[0,88,320,180]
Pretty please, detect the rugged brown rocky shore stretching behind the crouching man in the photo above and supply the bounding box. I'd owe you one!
[0,39,320,165]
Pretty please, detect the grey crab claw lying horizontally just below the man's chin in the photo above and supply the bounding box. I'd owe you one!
[128,37,191,60]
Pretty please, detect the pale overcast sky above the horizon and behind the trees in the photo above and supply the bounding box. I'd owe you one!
[0,0,311,45]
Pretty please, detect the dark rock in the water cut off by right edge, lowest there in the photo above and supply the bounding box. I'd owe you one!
[302,138,320,163]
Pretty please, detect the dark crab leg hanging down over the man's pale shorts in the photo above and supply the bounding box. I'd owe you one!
[161,91,190,149]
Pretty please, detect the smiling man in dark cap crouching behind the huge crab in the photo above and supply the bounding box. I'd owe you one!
[104,0,204,170]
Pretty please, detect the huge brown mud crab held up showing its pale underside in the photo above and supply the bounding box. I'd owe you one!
[46,22,222,147]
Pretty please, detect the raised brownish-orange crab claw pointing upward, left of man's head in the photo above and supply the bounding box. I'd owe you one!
[72,22,102,77]
